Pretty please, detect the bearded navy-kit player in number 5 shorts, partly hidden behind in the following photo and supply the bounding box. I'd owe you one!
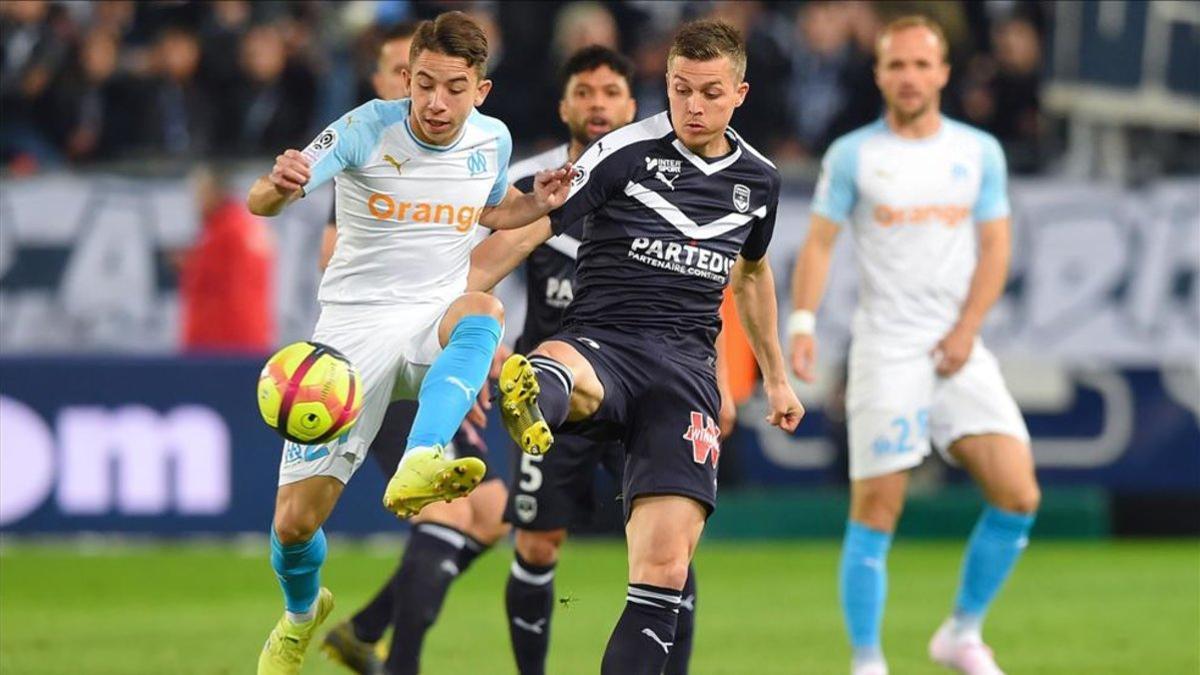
[479,46,710,675]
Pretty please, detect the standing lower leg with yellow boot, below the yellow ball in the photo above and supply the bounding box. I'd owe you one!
[258,476,344,675]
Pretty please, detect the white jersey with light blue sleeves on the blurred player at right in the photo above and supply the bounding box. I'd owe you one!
[812,117,1009,352]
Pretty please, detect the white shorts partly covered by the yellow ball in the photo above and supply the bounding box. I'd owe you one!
[280,303,450,485]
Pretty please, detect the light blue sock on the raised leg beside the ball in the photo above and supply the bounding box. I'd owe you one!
[408,315,500,448]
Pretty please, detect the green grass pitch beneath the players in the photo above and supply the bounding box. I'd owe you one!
[0,540,1200,675]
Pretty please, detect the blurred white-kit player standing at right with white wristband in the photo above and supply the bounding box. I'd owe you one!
[788,17,1039,675]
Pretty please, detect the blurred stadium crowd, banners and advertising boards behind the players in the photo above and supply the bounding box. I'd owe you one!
[0,0,1200,536]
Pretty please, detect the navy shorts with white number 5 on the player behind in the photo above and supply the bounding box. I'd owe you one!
[504,431,625,531]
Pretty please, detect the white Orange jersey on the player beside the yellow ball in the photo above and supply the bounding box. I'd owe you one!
[304,98,512,304]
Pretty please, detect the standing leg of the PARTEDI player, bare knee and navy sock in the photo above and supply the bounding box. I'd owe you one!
[600,495,707,675]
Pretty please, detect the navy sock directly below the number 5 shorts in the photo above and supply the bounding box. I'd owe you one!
[504,554,554,675]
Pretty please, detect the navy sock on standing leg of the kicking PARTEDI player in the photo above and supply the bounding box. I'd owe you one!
[600,584,680,675]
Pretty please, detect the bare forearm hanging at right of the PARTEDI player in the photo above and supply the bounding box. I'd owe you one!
[731,256,804,431]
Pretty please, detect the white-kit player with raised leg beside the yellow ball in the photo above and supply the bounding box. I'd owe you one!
[247,12,569,674]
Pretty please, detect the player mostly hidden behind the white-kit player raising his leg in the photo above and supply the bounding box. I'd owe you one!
[320,22,511,675]
